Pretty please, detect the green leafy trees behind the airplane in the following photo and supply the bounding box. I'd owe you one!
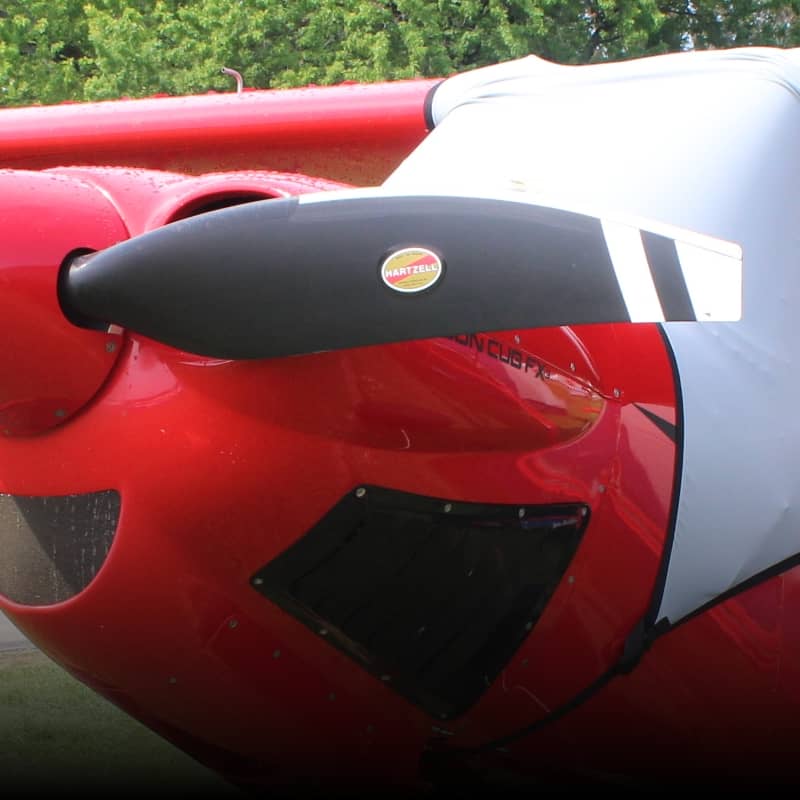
[0,0,800,105]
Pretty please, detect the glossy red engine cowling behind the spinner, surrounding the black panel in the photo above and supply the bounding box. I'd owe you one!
[0,162,675,785]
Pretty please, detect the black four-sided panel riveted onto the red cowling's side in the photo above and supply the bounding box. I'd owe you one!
[252,486,588,719]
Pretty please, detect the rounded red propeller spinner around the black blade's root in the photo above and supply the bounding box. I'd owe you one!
[0,170,129,437]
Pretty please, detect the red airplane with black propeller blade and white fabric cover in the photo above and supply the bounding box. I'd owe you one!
[0,48,800,794]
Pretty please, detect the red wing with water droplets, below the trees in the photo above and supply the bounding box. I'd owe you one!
[0,79,438,184]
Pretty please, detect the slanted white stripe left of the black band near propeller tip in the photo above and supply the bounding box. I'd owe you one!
[602,220,664,322]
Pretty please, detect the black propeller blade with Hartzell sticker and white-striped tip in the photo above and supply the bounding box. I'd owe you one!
[59,190,741,359]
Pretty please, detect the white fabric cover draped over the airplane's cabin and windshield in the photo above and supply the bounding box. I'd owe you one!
[384,48,800,623]
